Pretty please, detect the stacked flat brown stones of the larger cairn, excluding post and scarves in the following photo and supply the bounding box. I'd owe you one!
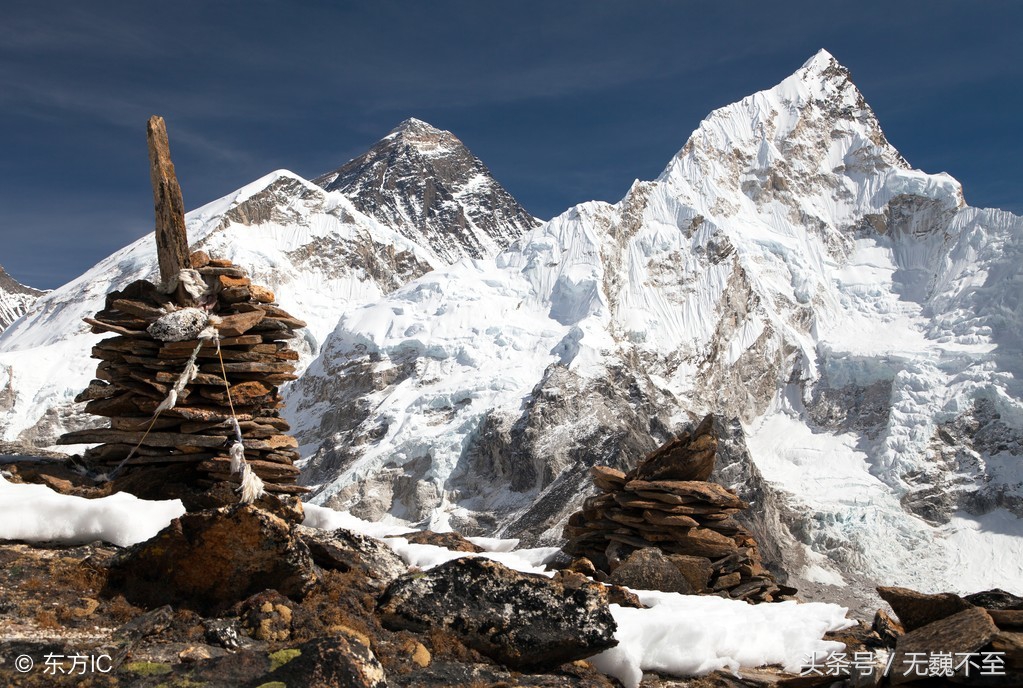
[59,251,307,494]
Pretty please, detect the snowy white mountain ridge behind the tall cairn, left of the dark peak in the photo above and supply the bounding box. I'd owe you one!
[0,170,438,447]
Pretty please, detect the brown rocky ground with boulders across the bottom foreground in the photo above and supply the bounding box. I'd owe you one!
[0,461,1023,688]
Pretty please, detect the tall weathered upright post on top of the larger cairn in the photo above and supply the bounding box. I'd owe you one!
[145,114,191,284]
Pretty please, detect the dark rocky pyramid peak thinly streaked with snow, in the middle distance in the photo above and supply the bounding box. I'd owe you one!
[313,119,540,263]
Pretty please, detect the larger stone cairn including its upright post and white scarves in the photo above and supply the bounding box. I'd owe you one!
[58,118,307,502]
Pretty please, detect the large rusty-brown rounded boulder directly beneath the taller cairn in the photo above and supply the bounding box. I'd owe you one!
[109,506,316,610]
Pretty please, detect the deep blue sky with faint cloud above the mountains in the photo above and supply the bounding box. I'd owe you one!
[0,0,1023,288]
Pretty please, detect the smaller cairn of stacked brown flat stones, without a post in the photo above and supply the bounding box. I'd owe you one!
[564,416,796,602]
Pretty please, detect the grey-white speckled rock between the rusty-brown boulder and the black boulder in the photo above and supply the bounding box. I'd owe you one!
[297,525,408,585]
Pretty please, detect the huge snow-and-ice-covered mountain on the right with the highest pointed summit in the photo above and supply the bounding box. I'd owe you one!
[290,51,1023,605]
